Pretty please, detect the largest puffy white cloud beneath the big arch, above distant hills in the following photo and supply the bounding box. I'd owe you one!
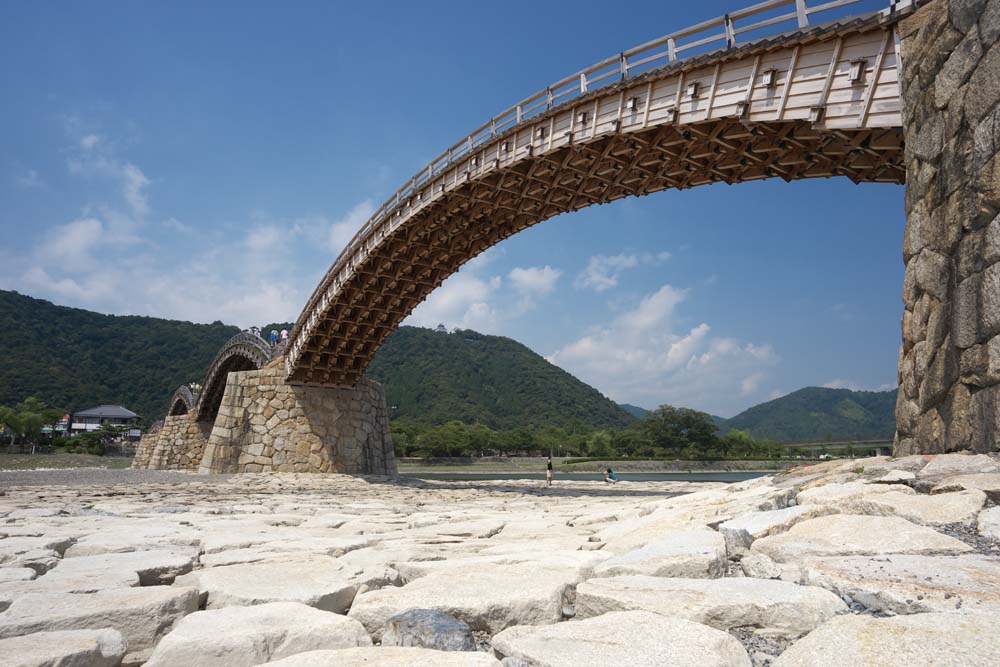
[549,285,778,415]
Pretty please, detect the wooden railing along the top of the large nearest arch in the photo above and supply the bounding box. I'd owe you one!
[291,0,914,378]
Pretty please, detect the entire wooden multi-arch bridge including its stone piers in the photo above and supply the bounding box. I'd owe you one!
[141,0,1000,474]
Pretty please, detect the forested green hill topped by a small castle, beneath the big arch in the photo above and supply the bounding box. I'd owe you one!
[368,327,633,430]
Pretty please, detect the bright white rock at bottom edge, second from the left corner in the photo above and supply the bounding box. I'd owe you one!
[146,602,372,667]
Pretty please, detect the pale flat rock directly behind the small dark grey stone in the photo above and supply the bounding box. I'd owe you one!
[348,565,578,641]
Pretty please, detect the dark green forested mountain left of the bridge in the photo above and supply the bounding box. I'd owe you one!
[0,290,239,421]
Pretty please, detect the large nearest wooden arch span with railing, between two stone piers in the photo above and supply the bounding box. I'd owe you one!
[284,0,909,386]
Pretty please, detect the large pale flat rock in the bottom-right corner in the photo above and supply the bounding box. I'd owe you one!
[772,613,1000,667]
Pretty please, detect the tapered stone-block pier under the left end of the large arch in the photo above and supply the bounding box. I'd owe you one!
[198,359,396,475]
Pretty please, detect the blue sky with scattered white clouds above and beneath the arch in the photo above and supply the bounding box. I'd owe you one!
[0,0,905,416]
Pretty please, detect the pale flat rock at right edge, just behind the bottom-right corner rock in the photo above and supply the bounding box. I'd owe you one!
[799,555,1000,614]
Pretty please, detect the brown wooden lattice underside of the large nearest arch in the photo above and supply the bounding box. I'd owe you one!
[290,118,905,386]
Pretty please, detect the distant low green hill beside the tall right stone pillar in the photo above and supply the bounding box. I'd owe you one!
[720,387,896,442]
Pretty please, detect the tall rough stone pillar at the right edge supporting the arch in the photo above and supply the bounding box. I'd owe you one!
[894,0,1000,456]
